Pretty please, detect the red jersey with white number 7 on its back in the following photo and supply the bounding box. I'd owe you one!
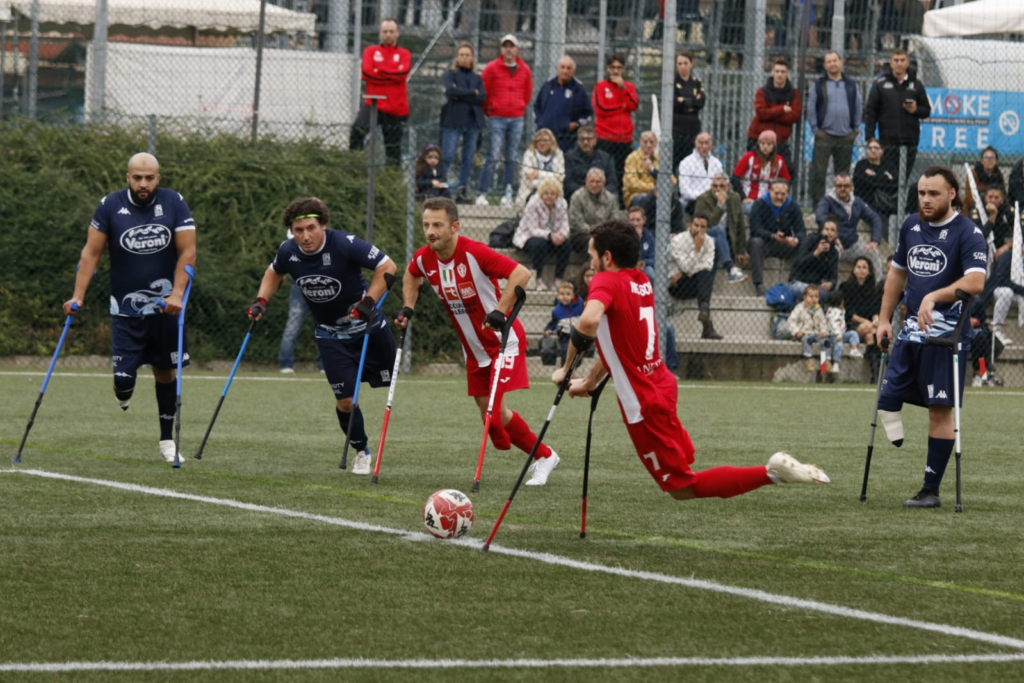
[587,268,676,424]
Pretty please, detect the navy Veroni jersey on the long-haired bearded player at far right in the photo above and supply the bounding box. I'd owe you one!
[893,213,988,341]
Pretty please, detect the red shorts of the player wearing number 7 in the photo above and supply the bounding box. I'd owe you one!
[626,401,696,490]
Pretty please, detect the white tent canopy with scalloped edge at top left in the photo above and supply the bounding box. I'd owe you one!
[0,0,316,34]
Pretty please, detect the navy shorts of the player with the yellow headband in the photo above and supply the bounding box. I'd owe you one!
[316,315,394,398]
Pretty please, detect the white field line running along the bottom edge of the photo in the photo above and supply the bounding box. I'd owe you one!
[0,654,1024,674]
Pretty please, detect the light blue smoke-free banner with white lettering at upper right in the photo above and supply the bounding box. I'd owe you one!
[918,88,1024,155]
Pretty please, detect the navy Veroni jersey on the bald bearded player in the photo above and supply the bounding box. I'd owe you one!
[89,187,196,317]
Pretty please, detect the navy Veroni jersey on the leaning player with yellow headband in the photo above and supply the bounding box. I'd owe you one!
[270,229,388,338]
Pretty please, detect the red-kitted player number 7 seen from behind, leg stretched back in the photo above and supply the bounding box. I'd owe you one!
[552,220,828,501]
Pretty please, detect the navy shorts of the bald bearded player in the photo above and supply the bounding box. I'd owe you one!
[111,314,188,373]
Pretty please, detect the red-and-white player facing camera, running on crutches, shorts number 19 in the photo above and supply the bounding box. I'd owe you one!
[395,198,559,486]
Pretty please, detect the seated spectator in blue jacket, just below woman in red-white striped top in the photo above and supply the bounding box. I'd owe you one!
[746,179,807,296]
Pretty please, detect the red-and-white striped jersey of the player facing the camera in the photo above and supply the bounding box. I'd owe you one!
[409,237,526,368]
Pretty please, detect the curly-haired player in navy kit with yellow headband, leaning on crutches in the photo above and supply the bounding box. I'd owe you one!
[246,197,396,474]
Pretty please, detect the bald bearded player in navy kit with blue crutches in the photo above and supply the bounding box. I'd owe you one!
[63,153,196,463]
